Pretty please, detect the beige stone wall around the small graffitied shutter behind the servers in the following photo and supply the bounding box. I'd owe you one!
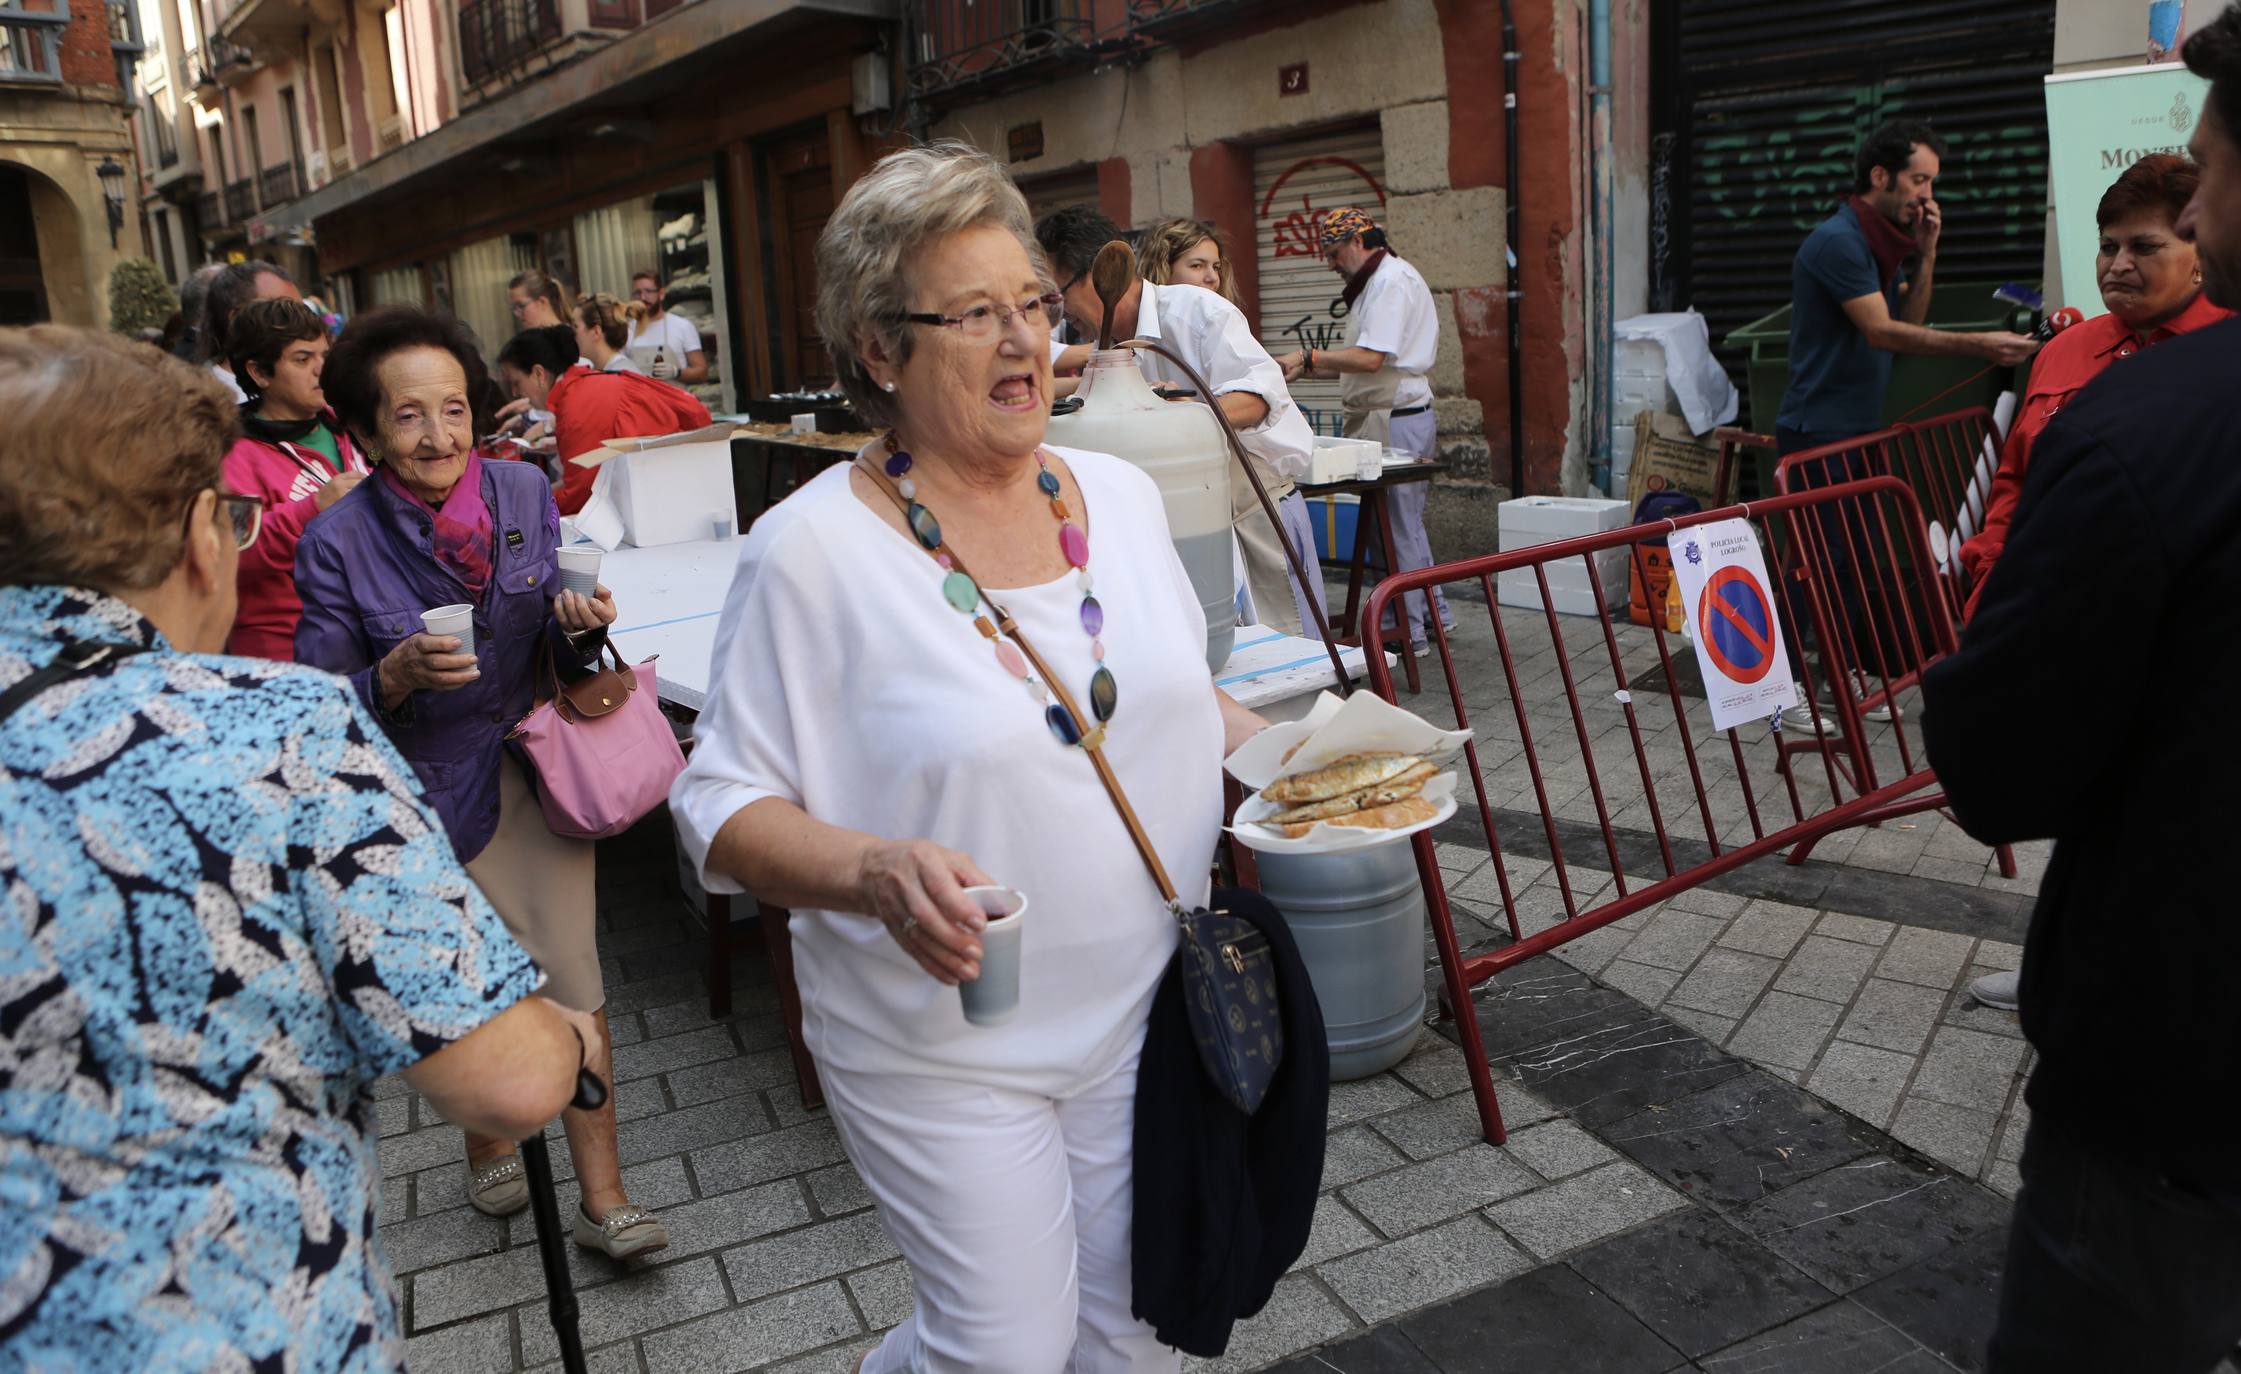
[932,0,1578,558]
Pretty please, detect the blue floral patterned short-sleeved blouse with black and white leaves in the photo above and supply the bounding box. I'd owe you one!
[0,587,542,1374]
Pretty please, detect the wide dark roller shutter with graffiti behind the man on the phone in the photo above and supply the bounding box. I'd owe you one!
[1649,0,2055,383]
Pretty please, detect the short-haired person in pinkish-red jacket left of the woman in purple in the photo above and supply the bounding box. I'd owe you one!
[226,296,368,663]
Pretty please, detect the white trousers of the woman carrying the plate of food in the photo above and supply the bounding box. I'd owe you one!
[818,1056,1183,1374]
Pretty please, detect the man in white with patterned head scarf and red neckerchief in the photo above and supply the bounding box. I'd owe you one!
[1277,206,1454,654]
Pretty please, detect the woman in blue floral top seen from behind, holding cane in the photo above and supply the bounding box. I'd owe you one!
[0,325,596,1374]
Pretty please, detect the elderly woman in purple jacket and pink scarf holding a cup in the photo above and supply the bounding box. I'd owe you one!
[296,307,670,1260]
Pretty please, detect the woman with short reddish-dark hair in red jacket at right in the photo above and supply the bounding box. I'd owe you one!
[1961,152,2234,616]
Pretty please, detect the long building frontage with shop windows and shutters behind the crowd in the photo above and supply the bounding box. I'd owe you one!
[87,0,2106,540]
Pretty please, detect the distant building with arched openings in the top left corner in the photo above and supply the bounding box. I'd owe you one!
[0,0,141,325]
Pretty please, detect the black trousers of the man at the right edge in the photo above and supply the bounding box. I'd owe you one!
[1990,1118,2241,1374]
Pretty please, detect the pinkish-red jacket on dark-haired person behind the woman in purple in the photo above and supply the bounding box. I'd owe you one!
[224,410,370,663]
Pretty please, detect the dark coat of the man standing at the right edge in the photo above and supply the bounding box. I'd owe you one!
[1923,321,2241,1188]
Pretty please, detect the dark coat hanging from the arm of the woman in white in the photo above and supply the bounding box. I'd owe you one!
[1132,890,1331,1356]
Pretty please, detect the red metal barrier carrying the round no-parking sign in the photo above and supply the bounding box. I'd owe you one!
[1365,477,2007,1145]
